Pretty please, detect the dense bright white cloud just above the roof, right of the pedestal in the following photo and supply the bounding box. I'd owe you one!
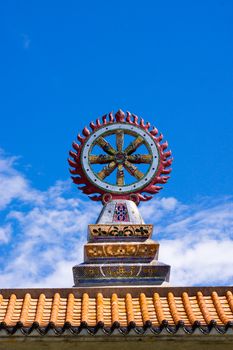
[160,238,233,286]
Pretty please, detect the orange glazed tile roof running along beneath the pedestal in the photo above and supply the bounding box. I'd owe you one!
[0,287,233,335]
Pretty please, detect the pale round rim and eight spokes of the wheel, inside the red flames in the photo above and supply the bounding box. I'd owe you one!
[82,123,159,193]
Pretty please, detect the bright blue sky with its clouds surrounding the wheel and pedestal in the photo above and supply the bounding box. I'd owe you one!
[0,0,233,286]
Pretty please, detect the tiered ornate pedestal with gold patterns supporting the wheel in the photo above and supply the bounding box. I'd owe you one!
[73,200,170,286]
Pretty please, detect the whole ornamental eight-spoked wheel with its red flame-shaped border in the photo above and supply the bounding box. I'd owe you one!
[68,110,172,204]
